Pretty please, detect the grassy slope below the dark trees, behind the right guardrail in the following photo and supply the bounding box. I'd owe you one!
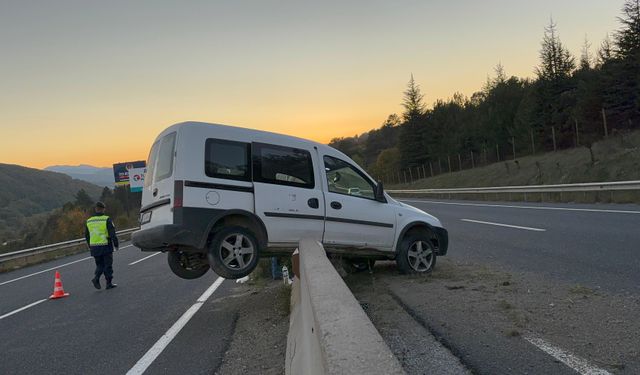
[388,131,640,200]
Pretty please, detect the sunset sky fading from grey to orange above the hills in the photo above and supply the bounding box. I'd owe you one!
[0,0,623,168]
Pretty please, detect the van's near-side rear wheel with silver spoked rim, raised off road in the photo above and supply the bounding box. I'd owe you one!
[207,226,260,279]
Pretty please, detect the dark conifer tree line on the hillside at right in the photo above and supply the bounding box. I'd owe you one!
[329,0,640,182]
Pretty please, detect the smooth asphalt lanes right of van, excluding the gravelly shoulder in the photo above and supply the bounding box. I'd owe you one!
[402,199,640,294]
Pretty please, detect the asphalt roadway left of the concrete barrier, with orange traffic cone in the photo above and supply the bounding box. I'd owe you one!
[0,244,237,374]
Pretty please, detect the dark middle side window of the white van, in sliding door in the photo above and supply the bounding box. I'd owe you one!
[253,143,315,189]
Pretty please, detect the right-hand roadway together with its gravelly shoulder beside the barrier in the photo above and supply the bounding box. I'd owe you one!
[384,199,640,374]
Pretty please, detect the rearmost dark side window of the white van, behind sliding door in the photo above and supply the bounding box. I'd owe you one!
[204,138,251,181]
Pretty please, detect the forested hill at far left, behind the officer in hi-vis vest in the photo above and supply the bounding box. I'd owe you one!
[0,164,102,244]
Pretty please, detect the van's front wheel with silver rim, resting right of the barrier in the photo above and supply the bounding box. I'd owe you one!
[396,231,436,274]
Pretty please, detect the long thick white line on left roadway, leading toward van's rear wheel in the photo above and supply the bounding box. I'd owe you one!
[127,277,225,375]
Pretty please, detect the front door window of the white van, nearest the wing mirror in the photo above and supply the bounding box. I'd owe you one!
[324,156,375,199]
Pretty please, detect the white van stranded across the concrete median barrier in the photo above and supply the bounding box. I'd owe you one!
[132,122,448,279]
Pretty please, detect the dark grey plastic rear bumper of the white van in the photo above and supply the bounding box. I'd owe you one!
[131,224,200,251]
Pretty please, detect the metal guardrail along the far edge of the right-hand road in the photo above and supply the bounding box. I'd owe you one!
[387,181,640,194]
